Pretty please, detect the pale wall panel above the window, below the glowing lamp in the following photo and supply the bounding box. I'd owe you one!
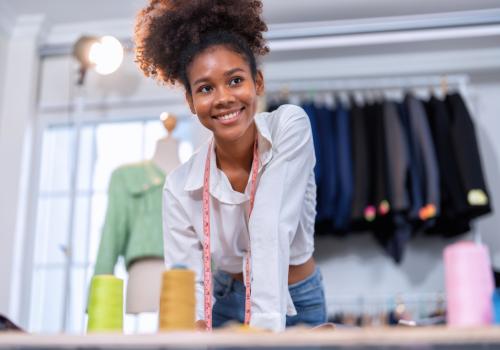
[38,53,196,130]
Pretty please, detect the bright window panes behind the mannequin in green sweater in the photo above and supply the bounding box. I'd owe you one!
[29,120,197,333]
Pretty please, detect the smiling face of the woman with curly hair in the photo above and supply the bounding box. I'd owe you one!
[186,45,264,143]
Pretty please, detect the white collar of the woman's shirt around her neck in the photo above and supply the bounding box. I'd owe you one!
[184,112,273,196]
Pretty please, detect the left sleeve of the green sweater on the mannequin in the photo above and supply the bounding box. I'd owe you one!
[94,171,129,275]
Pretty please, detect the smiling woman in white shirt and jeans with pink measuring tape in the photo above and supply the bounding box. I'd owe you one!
[136,0,326,331]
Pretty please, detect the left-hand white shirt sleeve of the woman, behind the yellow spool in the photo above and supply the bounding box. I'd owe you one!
[163,180,205,320]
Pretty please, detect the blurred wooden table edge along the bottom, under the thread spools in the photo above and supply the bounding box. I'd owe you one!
[0,327,500,350]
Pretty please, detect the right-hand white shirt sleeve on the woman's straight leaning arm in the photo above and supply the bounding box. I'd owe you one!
[249,106,316,331]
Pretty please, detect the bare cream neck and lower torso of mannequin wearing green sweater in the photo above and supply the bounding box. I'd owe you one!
[126,113,181,314]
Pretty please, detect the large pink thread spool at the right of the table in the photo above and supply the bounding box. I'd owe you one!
[444,241,493,327]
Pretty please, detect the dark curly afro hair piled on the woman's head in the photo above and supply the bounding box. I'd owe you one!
[135,0,269,93]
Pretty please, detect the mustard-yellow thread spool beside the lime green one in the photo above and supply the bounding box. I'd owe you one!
[159,268,196,331]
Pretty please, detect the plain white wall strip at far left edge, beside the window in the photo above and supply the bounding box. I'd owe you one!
[0,15,43,320]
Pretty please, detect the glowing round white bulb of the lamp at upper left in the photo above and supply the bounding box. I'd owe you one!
[89,36,123,75]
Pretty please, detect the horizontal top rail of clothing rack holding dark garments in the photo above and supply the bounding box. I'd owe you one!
[266,74,470,95]
